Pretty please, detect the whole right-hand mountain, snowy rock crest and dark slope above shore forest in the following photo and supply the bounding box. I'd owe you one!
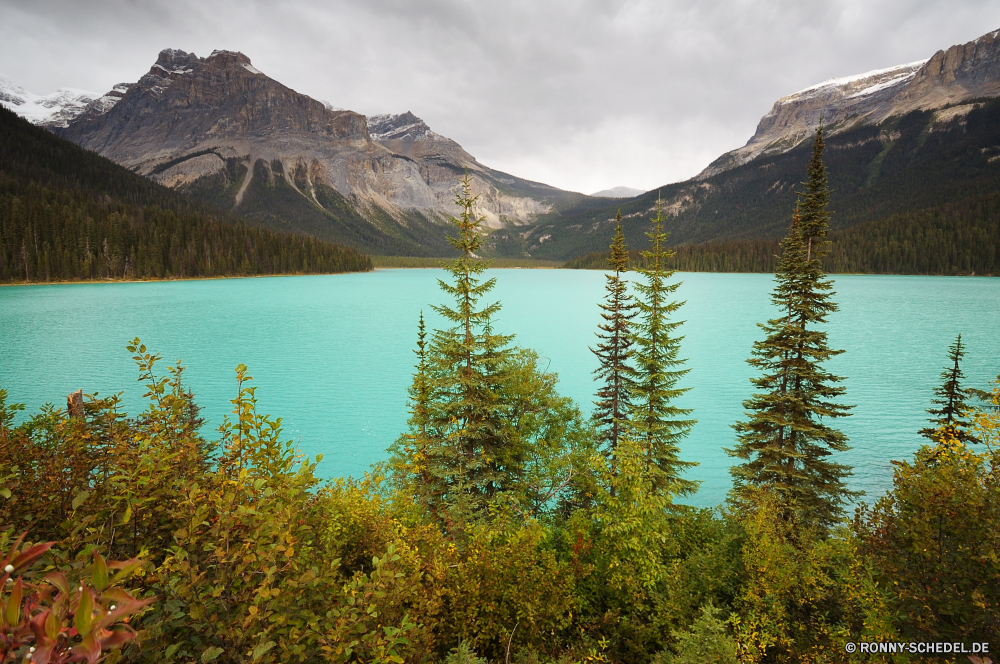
[498,31,1000,259]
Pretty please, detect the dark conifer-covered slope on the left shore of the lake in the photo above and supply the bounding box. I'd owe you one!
[0,109,371,282]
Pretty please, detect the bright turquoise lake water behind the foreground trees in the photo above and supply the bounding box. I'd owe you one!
[0,270,1000,506]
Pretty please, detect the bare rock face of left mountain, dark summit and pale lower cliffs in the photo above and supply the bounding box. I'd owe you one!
[41,49,566,246]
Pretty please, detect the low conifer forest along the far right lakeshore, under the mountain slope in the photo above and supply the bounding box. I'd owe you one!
[564,192,1000,275]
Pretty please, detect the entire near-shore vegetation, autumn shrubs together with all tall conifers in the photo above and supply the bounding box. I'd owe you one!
[0,127,1000,664]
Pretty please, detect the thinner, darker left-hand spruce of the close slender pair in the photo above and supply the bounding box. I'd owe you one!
[590,211,638,471]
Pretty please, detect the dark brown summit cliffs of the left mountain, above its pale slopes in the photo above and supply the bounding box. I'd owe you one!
[57,49,371,179]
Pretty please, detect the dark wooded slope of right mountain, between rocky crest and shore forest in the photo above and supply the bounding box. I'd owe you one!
[512,99,1000,262]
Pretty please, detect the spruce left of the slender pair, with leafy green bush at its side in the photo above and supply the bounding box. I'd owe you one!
[387,177,593,538]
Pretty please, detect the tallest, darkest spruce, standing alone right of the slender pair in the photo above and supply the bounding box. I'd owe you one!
[727,126,858,529]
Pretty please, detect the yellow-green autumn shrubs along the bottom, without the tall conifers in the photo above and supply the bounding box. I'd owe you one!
[0,340,1000,664]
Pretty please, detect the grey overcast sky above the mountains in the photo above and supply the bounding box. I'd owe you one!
[0,0,1000,193]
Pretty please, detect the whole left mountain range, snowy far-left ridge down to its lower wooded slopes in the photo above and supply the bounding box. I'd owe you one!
[9,49,586,255]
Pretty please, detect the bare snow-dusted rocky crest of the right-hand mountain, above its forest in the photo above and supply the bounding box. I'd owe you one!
[698,30,1000,180]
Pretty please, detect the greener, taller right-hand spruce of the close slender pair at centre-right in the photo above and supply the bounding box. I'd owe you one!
[628,199,698,495]
